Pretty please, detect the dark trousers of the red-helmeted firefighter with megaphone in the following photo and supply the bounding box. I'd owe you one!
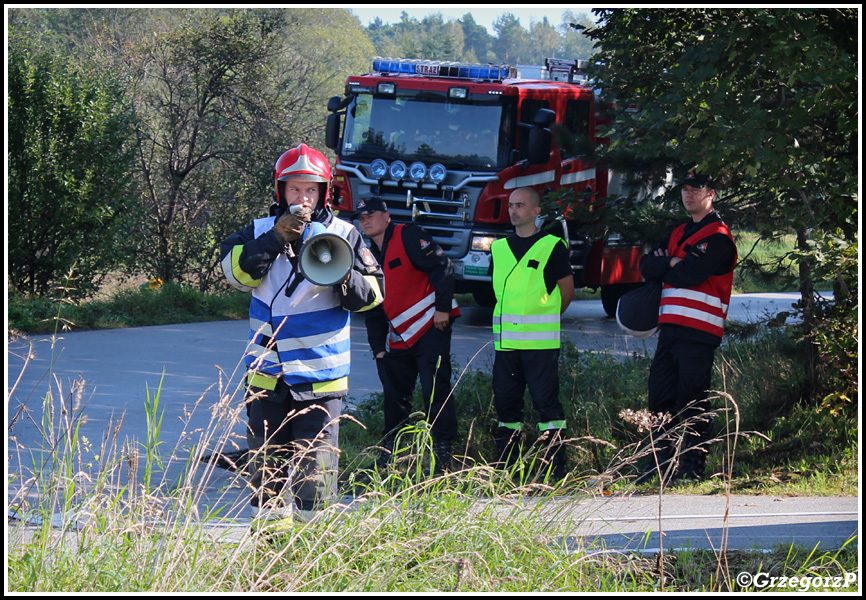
[246,379,343,510]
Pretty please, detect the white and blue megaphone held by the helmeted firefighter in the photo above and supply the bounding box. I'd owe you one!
[298,222,355,285]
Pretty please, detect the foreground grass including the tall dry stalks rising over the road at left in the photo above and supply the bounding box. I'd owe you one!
[7,391,859,593]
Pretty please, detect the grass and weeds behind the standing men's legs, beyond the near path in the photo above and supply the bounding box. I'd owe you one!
[340,329,859,496]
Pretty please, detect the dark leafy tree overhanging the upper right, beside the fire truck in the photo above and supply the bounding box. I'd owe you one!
[586,9,858,408]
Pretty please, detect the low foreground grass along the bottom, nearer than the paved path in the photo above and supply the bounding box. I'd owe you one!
[7,469,859,593]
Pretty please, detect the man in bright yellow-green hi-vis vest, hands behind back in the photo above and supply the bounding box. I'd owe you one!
[490,188,574,479]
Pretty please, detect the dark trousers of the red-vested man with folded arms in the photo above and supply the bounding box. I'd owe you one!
[648,327,716,475]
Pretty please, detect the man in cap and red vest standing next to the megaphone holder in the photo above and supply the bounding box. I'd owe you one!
[354,197,460,475]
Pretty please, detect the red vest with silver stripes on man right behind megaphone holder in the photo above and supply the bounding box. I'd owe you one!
[382,225,460,349]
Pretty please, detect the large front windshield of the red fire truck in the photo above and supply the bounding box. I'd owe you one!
[342,93,514,171]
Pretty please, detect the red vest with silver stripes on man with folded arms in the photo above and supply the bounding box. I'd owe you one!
[659,222,737,338]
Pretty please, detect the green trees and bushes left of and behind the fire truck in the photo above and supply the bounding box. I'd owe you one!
[8,8,592,298]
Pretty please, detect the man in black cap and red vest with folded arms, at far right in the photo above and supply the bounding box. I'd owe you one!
[638,171,737,483]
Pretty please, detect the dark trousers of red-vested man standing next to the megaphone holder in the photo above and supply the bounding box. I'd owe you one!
[376,327,457,442]
